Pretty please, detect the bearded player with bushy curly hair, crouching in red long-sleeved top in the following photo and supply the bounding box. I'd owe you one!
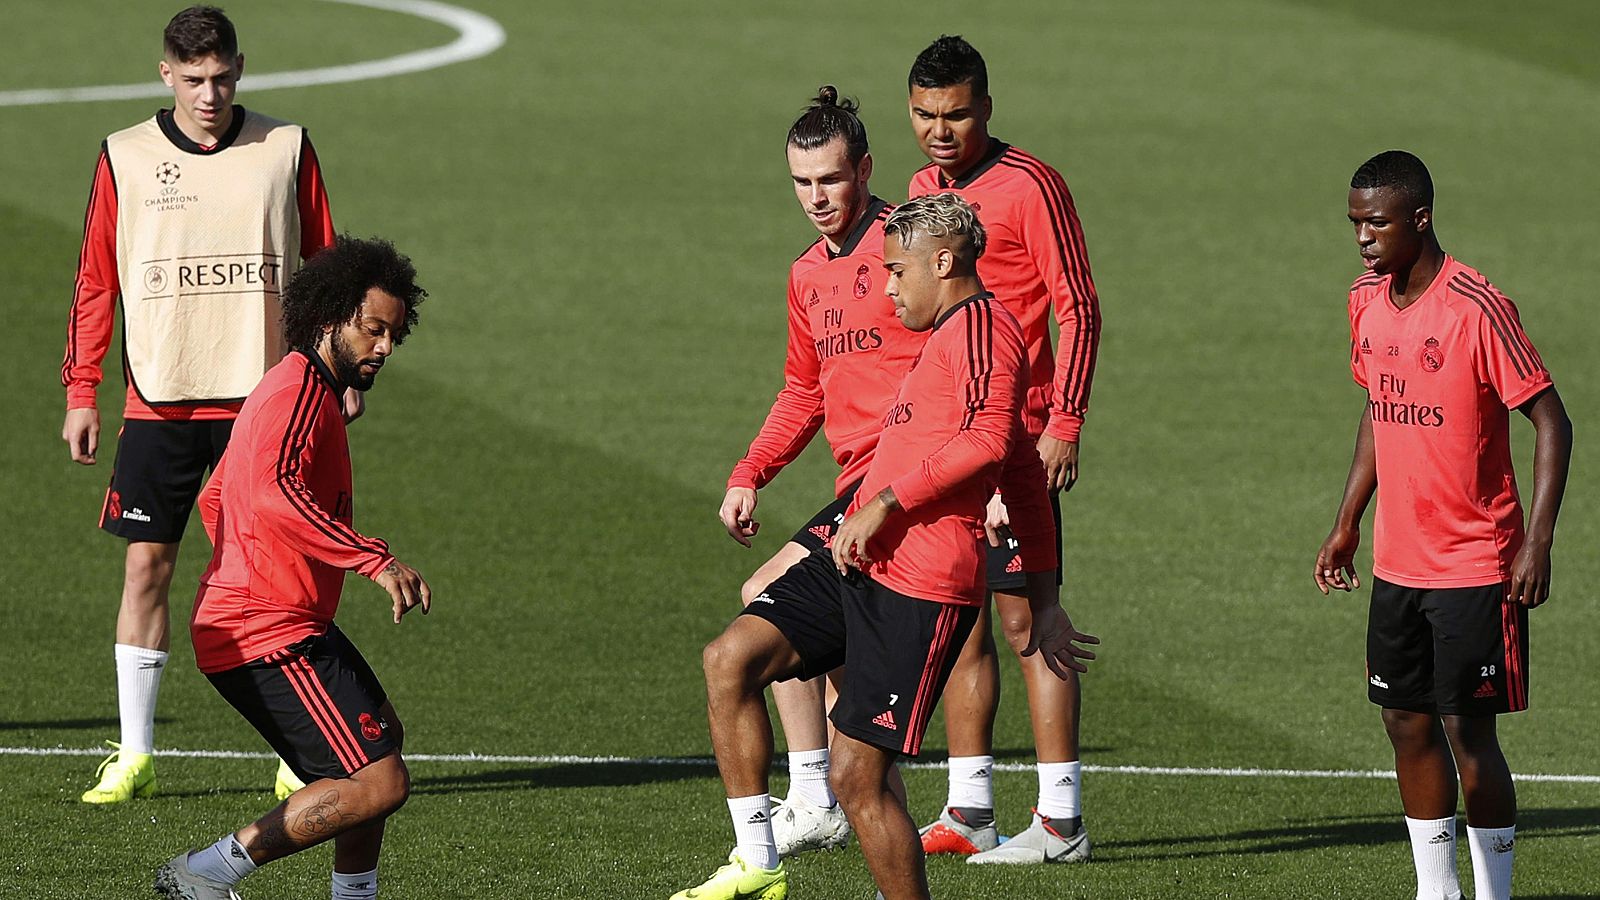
[155,237,432,900]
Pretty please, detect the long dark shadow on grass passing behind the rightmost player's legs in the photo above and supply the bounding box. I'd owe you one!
[1094,807,1600,860]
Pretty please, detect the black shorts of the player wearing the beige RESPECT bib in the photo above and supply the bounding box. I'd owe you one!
[101,420,234,544]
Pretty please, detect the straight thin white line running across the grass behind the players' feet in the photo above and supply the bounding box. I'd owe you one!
[0,746,1600,785]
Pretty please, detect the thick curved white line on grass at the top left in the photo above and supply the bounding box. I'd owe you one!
[0,0,506,106]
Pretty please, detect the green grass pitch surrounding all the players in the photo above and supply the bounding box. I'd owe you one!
[0,0,1600,900]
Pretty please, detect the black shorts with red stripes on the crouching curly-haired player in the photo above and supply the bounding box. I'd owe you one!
[206,625,398,781]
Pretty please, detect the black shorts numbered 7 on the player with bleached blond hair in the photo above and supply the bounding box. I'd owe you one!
[741,552,978,756]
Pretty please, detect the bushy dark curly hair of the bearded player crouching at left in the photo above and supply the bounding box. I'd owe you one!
[278,234,427,352]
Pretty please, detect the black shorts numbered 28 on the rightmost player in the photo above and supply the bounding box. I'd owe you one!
[1366,578,1528,716]
